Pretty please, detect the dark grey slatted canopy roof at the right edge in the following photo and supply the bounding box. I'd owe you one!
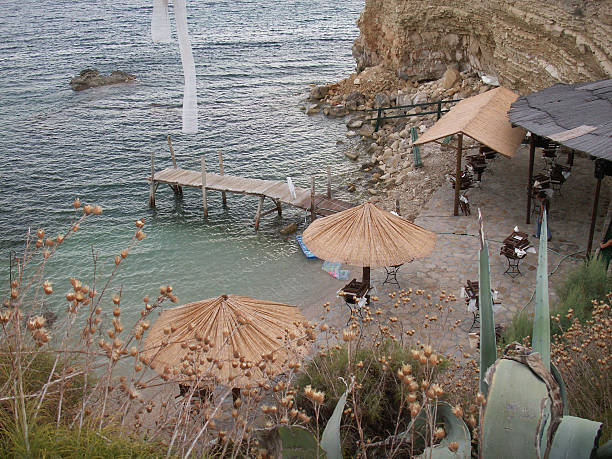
[509,79,612,160]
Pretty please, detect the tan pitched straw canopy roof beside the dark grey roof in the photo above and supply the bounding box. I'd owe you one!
[415,87,525,158]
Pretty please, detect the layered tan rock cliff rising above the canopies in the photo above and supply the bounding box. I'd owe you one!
[353,0,612,93]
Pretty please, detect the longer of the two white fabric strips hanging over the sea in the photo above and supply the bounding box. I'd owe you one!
[174,0,198,134]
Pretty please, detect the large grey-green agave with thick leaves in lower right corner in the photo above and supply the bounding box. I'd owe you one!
[480,212,612,459]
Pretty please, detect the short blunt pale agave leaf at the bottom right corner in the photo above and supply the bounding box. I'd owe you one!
[548,416,601,459]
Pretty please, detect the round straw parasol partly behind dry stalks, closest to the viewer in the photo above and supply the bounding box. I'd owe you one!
[143,295,314,388]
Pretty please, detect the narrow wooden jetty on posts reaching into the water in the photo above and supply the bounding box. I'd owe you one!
[147,138,353,230]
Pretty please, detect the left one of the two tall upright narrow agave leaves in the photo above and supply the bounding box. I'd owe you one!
[478,209,497,395]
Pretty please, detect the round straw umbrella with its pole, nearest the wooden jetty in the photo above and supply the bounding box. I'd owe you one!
[302,202,436,288]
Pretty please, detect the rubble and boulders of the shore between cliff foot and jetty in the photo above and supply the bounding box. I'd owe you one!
[303,66,493,220]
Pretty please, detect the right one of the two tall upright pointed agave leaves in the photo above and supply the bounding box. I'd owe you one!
[532,210,550,370]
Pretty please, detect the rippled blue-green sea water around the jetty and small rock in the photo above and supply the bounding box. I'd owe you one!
[0,0,363,324]
